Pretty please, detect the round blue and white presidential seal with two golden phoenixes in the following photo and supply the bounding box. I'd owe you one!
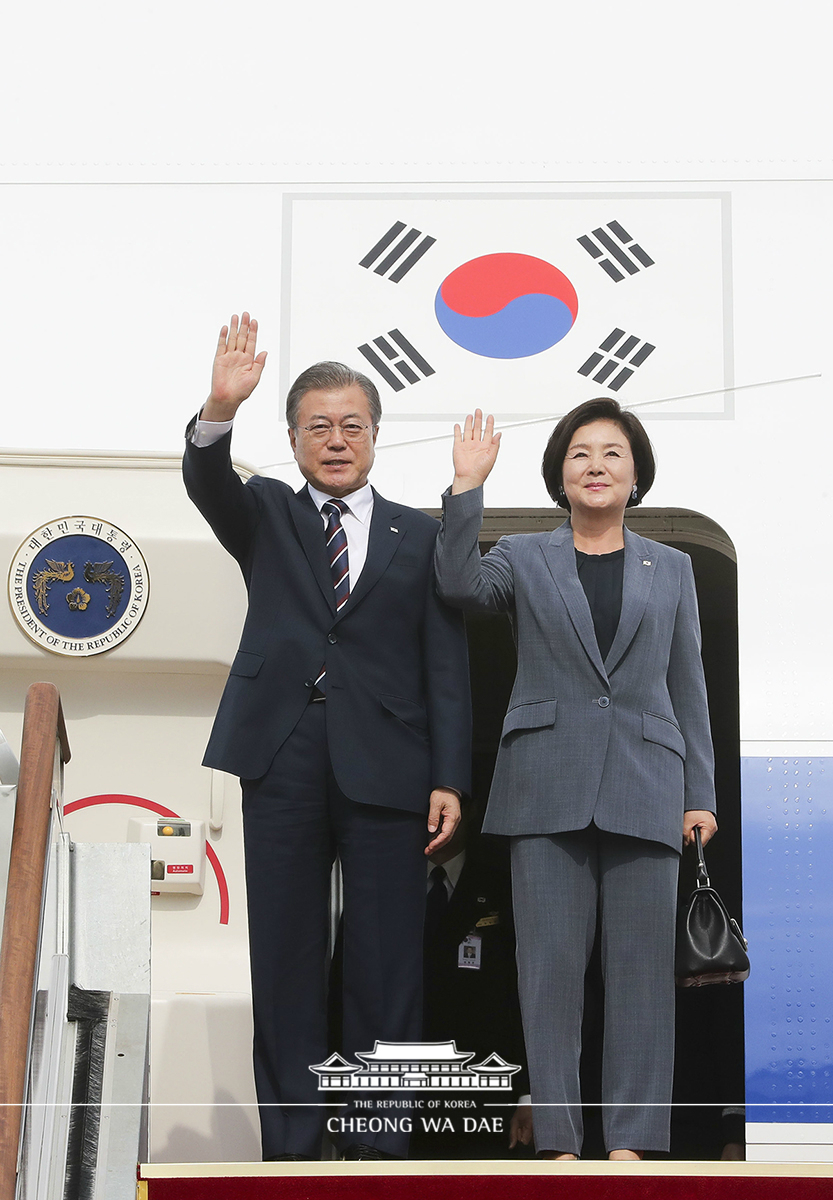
[8,517,150,658]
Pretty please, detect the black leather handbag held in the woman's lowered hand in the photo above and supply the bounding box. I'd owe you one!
[675,828,749,988]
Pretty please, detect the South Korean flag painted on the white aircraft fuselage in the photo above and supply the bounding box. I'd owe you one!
[281,191,732,421]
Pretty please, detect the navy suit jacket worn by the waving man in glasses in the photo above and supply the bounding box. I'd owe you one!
[184,433,471,812]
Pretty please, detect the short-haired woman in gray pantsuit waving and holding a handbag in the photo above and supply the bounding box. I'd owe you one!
[437,398,717,1159]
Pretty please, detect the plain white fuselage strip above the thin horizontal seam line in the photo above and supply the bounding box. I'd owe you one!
[2,0,831,177]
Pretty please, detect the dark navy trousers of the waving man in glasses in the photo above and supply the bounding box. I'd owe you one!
[242,703,426,1158]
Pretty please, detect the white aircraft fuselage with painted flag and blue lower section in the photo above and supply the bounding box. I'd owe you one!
[0,0,833,1162]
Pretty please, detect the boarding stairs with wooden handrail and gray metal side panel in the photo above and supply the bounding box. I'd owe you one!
[0,683,150,1200]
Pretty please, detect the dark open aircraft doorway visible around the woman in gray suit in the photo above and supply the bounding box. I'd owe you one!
[466,508,743,1159]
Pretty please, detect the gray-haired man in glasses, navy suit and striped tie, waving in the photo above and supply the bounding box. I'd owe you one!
[184,313,471,1159]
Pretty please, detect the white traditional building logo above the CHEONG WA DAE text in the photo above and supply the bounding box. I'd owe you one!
[310,1042,521,1092]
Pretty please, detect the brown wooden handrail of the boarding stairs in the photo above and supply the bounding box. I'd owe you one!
[0,683,70,1200]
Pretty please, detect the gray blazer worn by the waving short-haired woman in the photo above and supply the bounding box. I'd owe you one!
[436,488,715,850]
